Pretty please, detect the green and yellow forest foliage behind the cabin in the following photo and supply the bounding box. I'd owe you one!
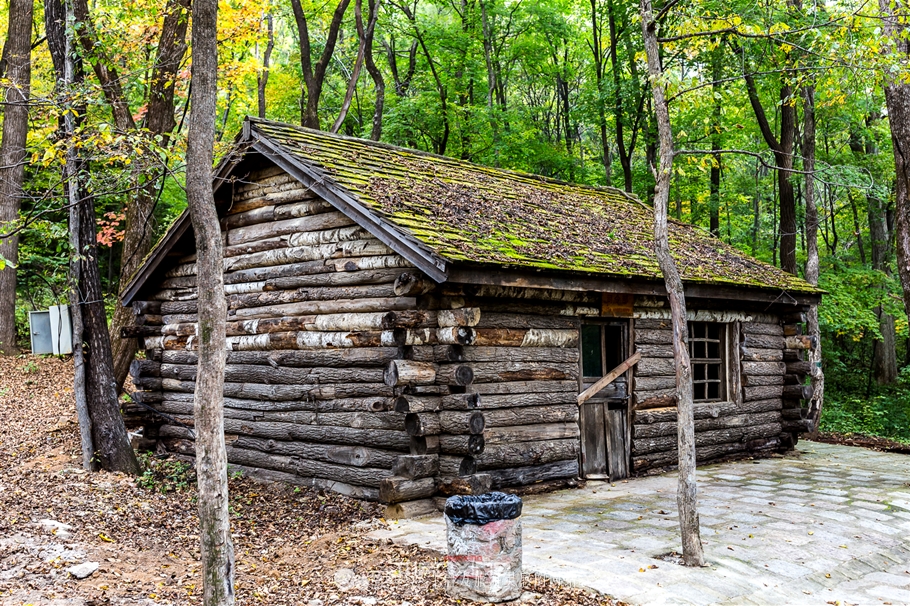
[0,0,910,442]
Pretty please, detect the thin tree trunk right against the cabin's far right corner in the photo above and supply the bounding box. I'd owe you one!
[802,84,825,432]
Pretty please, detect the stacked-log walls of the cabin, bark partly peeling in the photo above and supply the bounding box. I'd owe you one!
[125,160,813,508]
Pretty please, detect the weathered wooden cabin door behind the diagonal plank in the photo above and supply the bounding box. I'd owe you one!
[579,322,629,481]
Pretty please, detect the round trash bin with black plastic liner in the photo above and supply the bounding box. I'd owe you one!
[445,492,521,602]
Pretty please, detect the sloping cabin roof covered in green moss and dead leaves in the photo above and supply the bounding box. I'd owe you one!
[251,120,819,293]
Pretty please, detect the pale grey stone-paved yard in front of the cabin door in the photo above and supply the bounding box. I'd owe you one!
[374,442,910,604]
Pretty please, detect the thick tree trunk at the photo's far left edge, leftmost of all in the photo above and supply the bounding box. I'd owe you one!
[0,0,34,355]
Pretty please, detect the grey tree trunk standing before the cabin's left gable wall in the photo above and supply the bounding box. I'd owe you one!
[186,0,235,606]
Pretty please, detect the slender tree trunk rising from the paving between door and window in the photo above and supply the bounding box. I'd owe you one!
[641,0,705,566]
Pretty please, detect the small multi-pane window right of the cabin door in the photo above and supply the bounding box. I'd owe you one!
[689,322,727,402]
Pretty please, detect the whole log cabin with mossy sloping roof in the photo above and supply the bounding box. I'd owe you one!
[121,118,821,515]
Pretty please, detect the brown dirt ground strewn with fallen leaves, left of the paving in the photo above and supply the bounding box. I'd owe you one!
[0,356,616,606]
